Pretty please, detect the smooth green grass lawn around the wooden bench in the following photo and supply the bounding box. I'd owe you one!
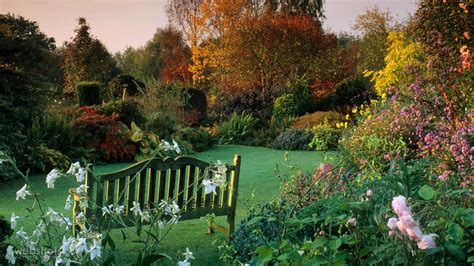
[0,145,335,265]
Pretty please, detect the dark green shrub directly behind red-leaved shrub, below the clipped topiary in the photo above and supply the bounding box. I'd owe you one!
[96,99,144,129]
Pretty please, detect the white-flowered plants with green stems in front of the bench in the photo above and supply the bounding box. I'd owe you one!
[0,147,227,265]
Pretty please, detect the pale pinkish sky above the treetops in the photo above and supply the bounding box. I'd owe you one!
[0,0,416,53]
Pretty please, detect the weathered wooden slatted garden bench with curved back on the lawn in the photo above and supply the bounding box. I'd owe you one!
[70,155,240,236]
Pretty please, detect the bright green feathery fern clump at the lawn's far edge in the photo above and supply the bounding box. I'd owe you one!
[219,112,256,144]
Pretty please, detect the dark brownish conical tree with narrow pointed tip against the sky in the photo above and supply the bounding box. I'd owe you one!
[63,18,119,94]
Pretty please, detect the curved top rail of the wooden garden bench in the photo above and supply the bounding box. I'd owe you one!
[99,156,235,181]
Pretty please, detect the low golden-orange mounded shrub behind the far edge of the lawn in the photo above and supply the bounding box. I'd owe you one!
[291,111,344,129]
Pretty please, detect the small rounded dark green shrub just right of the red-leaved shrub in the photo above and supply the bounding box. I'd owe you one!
[145,112,178,139]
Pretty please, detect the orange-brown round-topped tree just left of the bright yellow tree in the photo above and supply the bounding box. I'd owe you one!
[353,6,399,71]
